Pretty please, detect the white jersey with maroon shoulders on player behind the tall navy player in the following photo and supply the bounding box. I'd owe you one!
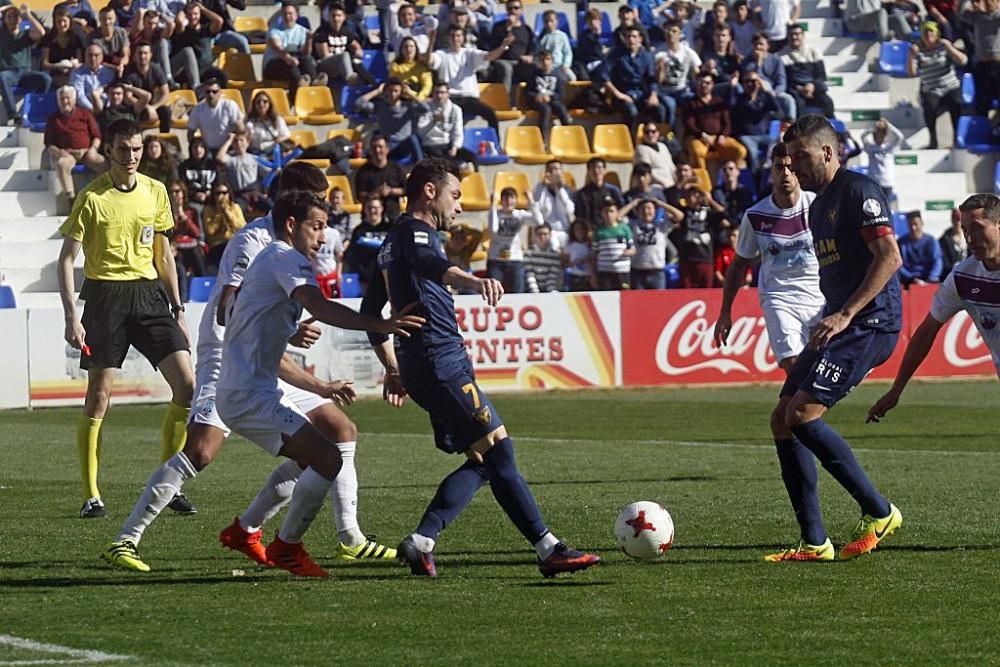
[736,192,824,308]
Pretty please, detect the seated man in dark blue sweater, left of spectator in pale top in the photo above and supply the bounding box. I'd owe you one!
[607,28,667,132]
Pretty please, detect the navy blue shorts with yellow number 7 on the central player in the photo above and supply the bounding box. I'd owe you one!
[403,370,503,454]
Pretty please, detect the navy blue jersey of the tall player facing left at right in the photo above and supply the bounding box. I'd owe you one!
[809,169,903,332]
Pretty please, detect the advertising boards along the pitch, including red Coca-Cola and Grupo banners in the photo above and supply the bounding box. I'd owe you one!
[0,286,995,408]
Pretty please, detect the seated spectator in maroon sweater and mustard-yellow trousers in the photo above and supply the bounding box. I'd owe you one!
[684,74,747,169]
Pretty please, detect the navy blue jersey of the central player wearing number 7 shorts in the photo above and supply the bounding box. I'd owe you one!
[361,214,470,378]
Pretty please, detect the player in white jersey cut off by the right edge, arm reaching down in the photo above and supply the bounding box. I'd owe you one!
[867,194,1000,422]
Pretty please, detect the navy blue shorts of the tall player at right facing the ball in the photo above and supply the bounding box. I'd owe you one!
[781,325,899,408]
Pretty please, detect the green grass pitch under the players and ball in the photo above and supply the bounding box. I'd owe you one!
[0,381,1000,666]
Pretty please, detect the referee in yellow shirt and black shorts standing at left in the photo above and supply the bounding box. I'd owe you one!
[59,119,195,518]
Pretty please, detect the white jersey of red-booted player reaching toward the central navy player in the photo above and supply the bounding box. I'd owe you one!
[219,240,318,395]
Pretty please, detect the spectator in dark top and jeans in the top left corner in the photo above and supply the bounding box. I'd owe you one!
[0,5,52,121]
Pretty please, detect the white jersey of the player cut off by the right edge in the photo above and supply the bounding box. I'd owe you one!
[931,257,1000,377]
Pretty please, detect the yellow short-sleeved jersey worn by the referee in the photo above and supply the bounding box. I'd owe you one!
[59,172,174,280]
